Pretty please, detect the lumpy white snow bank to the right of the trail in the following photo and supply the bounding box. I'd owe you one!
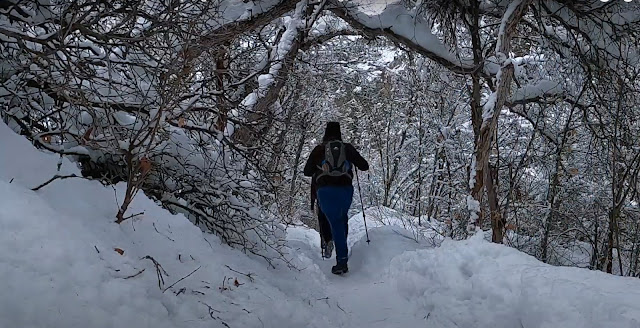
[390,234,640,328]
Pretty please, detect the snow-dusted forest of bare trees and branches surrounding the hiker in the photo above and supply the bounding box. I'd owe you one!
[0,0,640,327]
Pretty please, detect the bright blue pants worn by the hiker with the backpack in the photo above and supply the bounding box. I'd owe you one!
[318,186,353,263]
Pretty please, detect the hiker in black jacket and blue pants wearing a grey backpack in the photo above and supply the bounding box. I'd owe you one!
[304,122,369,274]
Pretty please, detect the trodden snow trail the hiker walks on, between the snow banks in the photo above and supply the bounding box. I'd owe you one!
[289,219,427,328]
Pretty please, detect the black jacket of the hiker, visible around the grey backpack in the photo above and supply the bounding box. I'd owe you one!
[304,142,369,188]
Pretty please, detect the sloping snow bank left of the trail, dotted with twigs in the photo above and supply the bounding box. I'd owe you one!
[0,124,332,328]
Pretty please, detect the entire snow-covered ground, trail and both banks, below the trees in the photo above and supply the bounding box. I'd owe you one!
[0,124,640,328]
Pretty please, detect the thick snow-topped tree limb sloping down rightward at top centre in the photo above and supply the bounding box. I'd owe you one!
[331,1,475,73]
